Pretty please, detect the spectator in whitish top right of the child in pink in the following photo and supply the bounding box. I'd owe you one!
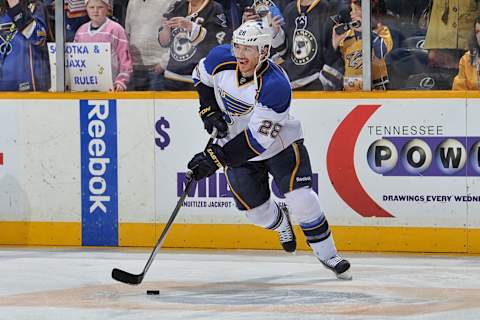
[125,0,169,91]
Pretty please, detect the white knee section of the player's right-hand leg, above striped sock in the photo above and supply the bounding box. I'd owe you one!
[285,188,323,223]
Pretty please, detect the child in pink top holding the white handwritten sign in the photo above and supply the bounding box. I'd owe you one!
[75,0,132,91]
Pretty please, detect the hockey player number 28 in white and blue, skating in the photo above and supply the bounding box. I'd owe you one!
[188,21,350,279]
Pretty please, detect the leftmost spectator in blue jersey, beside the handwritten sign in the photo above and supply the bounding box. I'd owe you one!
[0,0,50,91]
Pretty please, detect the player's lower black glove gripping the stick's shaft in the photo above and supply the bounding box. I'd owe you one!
[188,144,225,181]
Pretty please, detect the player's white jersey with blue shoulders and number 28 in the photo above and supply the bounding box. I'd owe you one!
[192,45,303,161]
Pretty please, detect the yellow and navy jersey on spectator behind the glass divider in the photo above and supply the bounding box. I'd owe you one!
[339,26,393,91]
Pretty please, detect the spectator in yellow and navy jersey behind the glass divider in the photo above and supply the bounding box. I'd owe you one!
[332,0,393,91]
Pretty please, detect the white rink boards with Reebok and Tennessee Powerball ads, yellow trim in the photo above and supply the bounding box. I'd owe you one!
[0,92,480,253]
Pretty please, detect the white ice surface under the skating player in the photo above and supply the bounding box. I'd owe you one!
[0,247,480,320]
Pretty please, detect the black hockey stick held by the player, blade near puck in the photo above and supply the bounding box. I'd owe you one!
[112,134,216,285]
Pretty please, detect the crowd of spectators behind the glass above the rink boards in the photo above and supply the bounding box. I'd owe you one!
[0,0,480,91]
